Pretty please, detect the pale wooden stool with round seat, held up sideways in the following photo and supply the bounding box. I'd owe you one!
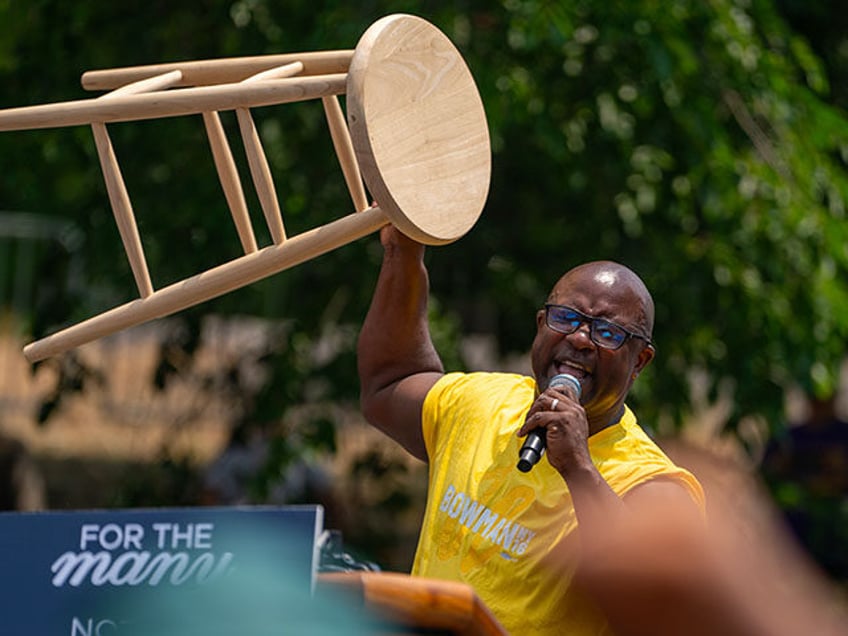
[0,14,491,362]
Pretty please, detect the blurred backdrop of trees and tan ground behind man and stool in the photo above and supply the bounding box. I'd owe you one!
[0,0,848,590]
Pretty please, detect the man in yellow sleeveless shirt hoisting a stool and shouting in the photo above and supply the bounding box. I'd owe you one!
[358,227,703,635]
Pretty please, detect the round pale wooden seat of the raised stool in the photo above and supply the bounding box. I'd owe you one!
[347,15,491,245]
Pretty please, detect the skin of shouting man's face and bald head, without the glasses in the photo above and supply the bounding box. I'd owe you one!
[531,267,654,424]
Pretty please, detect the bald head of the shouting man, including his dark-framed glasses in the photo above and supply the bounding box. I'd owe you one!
[531,261,654,432]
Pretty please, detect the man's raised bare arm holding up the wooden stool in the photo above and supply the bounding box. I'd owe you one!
[357,225,444,461]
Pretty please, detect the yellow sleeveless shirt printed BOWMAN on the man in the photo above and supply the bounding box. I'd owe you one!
[412,373,703,636]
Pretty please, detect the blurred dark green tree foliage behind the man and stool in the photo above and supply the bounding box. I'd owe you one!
[0,0,848,568]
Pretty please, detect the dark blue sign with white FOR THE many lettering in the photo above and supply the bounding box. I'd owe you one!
[0,506,374,636]
